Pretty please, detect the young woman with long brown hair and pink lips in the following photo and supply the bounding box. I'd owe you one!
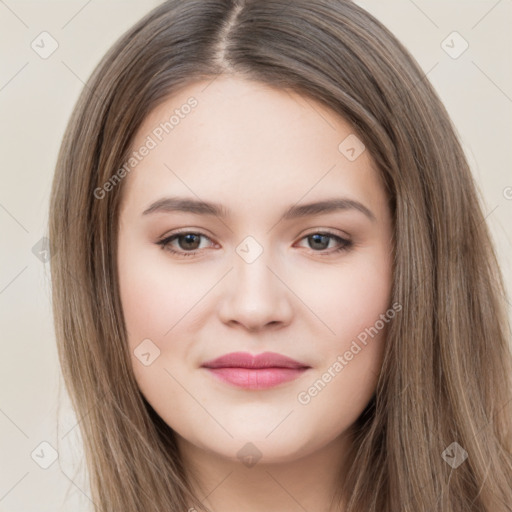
[50,0,512,512]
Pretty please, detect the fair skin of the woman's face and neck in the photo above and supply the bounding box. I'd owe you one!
[118,76,392,512]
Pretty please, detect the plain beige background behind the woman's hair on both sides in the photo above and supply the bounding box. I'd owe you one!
[0,0,512,512]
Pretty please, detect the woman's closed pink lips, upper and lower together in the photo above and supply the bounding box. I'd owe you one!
[202,352,310,389]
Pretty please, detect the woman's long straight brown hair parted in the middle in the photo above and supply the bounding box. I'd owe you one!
[49,0,512,512]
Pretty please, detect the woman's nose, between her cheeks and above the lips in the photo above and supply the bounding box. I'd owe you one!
[219,245,293,331]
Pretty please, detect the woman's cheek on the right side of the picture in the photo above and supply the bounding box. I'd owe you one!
[290,247,399,416]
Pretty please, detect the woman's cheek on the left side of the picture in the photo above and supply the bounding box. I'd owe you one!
[118,240,219,404]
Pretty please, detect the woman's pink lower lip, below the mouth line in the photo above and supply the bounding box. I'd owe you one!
[207,368,307,389]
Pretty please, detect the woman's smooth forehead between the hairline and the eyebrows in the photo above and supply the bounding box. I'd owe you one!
[119,76,382,218]
